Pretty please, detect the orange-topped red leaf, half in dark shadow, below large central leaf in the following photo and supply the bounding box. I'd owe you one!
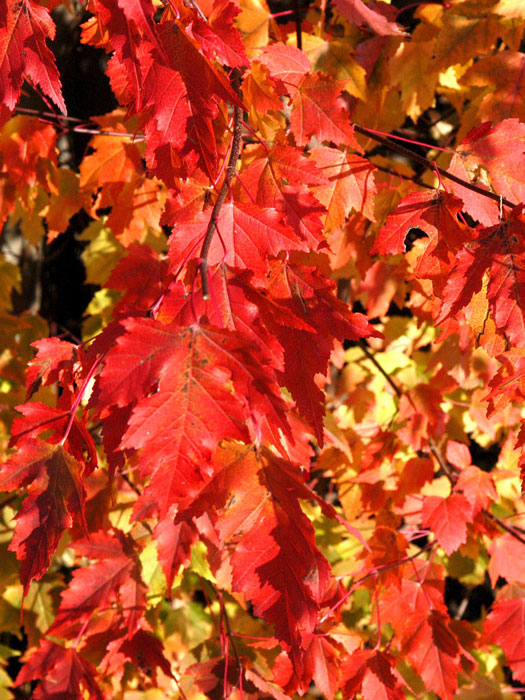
[164,443,333,673]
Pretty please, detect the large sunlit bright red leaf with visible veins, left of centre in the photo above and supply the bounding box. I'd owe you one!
[92,319,289,516]
